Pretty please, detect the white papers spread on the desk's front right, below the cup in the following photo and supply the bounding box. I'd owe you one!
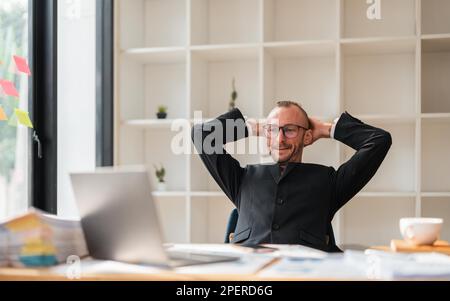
[260,250,450,280]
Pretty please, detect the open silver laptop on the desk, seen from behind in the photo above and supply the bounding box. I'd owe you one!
[70,167,239,267]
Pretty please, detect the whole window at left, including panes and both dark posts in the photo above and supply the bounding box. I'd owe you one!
[0,0,114,219]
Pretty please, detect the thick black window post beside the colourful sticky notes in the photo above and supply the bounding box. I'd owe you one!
[28,0,58,214]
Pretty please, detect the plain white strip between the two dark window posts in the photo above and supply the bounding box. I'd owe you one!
[58,0,95,217]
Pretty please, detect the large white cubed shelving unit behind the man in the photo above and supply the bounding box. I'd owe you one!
[115,0,450,245]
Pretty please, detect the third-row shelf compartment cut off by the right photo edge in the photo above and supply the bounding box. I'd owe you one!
[421,120,450,192]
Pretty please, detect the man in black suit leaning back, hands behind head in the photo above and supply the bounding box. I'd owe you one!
[192,101,392,252]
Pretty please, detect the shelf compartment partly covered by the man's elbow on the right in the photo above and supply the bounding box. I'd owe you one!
[342,123,416,193]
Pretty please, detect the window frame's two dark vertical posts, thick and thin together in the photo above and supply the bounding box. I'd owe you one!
[28,0,114,214]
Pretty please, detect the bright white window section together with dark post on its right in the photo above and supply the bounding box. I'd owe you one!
[57,0,113,217]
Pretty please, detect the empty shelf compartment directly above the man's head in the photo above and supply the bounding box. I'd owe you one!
[263,42,339,118]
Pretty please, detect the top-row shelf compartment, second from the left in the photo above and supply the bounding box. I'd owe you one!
[191,0,261,45]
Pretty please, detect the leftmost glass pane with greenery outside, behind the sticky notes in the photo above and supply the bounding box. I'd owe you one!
[0,0,30,219]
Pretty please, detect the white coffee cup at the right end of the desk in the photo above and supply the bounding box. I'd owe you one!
[400,217,444,246]
